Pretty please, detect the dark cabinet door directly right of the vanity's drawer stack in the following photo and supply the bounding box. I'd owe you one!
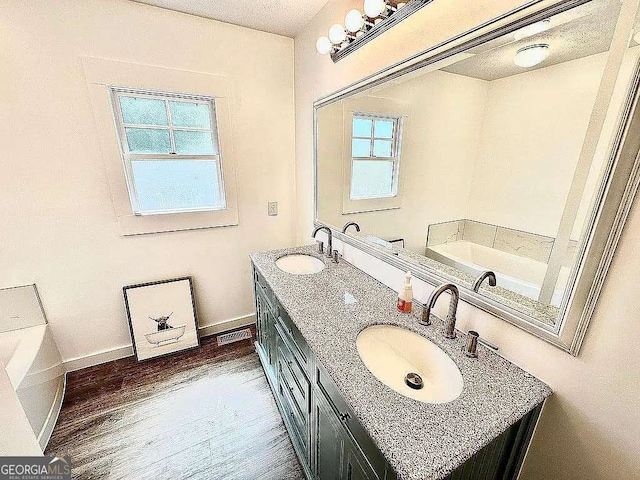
[312,392,346,480]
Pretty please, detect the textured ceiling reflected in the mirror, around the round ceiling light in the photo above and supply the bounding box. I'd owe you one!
[442,0,620,81]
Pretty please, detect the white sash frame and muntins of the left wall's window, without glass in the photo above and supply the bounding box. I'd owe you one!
[110,87,226,216]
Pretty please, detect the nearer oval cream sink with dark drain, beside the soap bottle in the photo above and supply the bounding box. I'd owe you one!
[356,325,463,403]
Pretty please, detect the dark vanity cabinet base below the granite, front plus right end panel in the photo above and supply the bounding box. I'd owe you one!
[253,269,541,480]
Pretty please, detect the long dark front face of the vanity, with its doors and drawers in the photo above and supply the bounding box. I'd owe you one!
[254,270,396,480]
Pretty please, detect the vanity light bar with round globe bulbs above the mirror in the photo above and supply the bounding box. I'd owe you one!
[316,0,433,62]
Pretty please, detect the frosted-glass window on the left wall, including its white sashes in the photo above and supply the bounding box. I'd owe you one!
[111,88,226,215]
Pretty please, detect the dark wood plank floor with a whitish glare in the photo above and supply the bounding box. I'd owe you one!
[46,332,304,480]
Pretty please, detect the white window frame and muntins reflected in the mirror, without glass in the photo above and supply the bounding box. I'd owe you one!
[349,112,402,201]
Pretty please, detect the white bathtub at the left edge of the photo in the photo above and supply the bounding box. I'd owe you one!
[0,324,65,456]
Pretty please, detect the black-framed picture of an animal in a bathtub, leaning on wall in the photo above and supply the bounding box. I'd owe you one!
[122,277,200,362]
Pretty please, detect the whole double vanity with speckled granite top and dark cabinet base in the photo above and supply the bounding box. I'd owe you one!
[251,247,551,480]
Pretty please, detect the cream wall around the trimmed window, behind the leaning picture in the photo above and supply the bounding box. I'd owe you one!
[0,0,295,366]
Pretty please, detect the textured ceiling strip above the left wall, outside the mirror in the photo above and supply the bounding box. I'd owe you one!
[134,0,328,37]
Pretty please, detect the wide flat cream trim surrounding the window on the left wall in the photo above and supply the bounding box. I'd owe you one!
[80,57,239,236]
